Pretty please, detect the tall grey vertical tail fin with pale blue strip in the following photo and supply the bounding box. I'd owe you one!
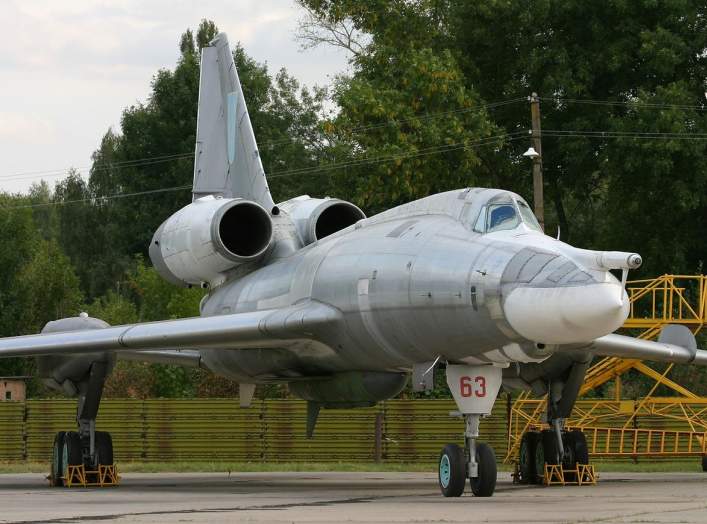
[192,33,274,211]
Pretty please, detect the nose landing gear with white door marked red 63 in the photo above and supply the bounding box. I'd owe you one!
[438,365,501,497]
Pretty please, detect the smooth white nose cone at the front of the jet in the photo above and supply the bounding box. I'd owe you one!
[503,256,629,344]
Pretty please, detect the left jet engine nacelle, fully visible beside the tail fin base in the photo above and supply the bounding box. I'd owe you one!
[150,195,273,286]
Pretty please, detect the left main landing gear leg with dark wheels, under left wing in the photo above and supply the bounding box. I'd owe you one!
[50,362,113,486]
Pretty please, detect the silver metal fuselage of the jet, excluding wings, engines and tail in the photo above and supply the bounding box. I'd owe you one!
[201,189,626,382]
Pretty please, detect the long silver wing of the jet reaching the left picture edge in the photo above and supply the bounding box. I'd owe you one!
[0,302,341,361]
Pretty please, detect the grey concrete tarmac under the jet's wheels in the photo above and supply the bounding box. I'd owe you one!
[0,473,707,524]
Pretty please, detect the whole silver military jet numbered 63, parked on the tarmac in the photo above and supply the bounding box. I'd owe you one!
[0,34,707,496]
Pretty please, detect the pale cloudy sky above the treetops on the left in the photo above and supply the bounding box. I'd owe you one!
[0,0,347,192]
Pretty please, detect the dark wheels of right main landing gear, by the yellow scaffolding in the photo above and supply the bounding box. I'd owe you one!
[518,429,589,484]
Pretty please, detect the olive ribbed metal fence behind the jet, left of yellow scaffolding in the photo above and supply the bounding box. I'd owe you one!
[0,399,508,462]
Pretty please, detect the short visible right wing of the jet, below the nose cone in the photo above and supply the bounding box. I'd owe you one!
[563,325,707,366]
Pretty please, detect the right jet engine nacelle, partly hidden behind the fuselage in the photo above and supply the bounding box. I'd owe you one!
[278,195,366,245]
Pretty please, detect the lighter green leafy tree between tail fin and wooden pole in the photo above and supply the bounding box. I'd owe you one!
[328,46,502,212]
